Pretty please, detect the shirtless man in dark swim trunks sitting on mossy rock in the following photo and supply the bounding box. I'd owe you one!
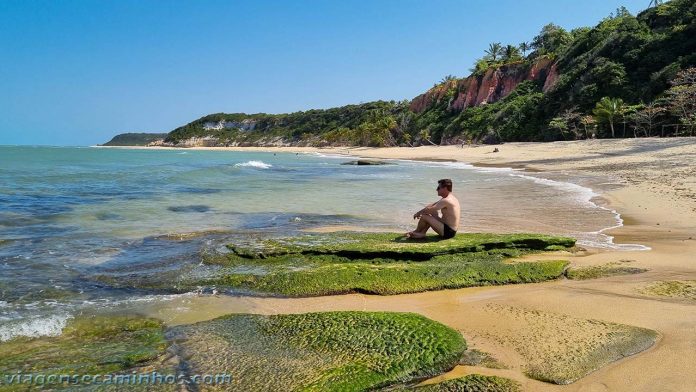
[406,179,461,239]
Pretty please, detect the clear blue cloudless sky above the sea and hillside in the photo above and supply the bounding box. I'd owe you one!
[0,0,650,145]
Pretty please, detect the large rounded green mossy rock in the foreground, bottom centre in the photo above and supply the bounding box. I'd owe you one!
[170,312,466,391]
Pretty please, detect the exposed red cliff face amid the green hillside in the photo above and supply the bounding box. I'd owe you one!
[410,59,558,113]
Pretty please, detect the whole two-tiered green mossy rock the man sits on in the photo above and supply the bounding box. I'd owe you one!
[189,233,574,297]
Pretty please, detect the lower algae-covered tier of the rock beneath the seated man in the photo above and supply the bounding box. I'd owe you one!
[203,252,567,297]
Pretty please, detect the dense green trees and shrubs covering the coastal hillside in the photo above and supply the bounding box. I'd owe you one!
[135,0,696,146]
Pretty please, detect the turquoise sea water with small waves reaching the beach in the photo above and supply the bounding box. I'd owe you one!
[0,146,632,340]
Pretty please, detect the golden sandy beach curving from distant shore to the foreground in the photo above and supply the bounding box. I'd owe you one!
[126,138,696,391]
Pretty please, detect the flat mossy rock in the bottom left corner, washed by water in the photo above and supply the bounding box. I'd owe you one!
[0,316,173,391]
